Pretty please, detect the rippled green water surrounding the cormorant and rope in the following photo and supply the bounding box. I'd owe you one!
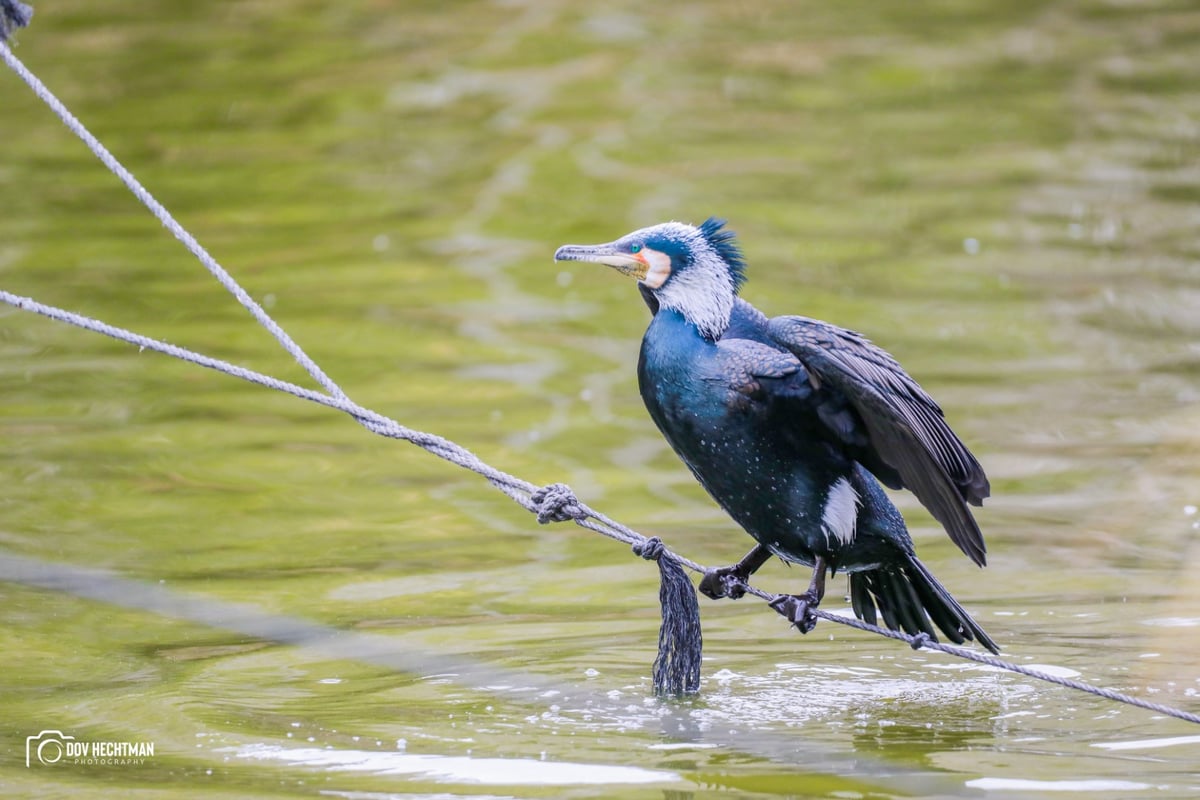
[0,0,1200,800]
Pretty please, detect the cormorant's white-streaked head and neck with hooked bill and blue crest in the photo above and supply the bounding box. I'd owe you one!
[554,217,745,341]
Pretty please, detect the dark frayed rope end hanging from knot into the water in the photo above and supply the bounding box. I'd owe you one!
[634,536,703,697]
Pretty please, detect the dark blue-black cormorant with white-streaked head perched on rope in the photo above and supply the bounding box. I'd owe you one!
[554,218,998,652]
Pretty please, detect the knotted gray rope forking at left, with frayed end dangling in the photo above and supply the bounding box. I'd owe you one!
[0,20,1200,723]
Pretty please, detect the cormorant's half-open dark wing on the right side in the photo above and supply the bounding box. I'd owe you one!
[768,317,990,566]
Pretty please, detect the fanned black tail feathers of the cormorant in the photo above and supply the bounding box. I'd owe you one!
[850,555,1000,652]
